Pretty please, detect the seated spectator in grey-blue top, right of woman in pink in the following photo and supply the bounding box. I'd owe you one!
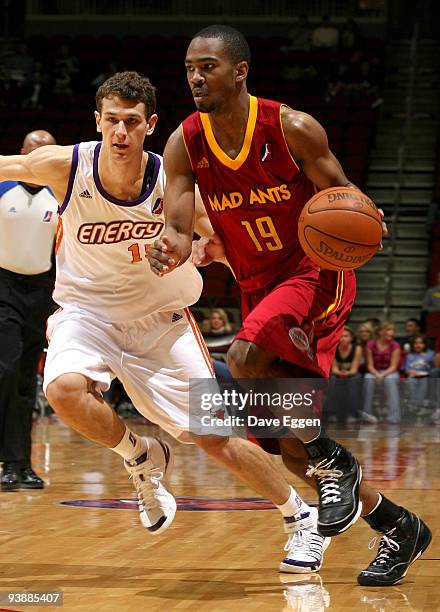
[405,334,435,403]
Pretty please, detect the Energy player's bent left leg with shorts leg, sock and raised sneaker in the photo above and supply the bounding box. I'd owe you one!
[43,309,176,533]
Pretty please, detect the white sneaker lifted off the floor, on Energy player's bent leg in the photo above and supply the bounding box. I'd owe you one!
[124,438,177,535]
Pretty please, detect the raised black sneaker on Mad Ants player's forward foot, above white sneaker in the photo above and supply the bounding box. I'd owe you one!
[304,438,362,537]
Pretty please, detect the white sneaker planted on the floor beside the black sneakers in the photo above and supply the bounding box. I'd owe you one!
[280,508,331,574]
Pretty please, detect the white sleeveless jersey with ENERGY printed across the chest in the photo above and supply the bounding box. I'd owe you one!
[54,142,202,322]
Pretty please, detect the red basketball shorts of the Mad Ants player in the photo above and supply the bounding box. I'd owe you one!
[236,264,356,378]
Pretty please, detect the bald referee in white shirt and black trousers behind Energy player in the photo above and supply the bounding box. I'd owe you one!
[0,130,58,491]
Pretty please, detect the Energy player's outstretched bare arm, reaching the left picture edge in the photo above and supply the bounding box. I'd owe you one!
[0,145,72,195]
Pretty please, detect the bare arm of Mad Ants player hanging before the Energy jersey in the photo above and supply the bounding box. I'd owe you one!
[148,127,195,276]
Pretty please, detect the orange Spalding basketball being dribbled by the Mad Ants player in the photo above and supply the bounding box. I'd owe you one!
[298,187,382,270]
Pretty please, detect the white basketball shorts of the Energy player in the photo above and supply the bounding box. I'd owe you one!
[43,307,214,442]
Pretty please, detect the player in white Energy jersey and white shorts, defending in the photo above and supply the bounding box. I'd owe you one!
[0,72,329,573]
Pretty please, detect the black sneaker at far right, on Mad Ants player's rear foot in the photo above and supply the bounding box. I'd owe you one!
[358,509,432,586]
